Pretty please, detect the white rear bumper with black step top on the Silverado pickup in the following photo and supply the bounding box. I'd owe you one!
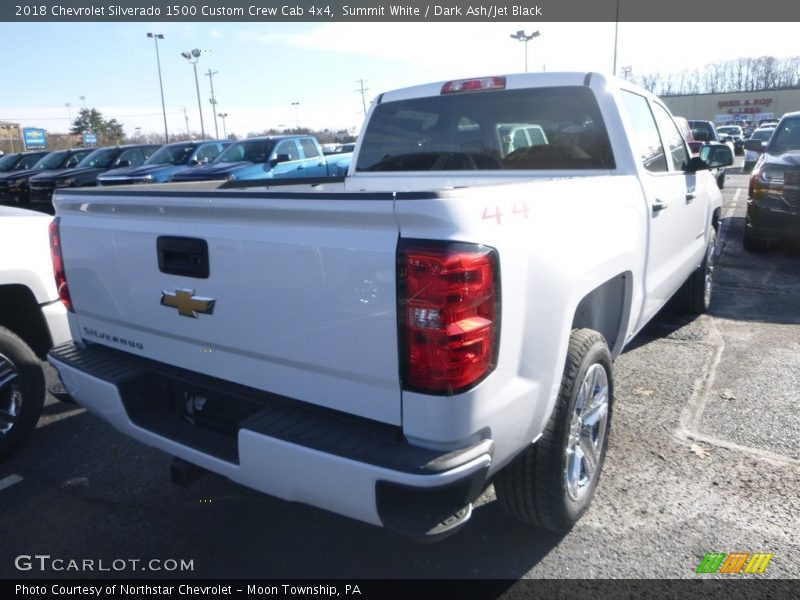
[48,343,494,537]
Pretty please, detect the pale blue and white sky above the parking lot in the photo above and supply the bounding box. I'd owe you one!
[0,22,800,136]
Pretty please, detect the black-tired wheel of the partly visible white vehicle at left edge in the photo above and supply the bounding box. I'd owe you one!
[0,327,45,458]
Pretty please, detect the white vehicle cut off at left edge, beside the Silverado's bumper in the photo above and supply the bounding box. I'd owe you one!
[0,206,70,458]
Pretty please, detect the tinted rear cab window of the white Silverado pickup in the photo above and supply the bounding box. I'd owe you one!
[356,86,614,172]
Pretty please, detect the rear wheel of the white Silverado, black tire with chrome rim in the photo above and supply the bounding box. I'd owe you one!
[494,329,613,532]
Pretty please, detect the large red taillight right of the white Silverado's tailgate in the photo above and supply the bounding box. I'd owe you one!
[398,241,500,394]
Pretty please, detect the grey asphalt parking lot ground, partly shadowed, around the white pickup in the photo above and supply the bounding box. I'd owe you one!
[0,157,800,579]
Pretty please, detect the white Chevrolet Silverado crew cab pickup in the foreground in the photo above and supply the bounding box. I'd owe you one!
[45,73,732,537]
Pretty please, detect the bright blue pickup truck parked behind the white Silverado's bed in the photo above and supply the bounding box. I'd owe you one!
[170,135,328,181]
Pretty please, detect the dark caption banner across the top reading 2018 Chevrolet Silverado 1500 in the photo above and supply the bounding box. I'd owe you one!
[0,0,800,22]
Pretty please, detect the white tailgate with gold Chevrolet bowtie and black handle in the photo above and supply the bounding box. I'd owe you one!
[56,191,401,425]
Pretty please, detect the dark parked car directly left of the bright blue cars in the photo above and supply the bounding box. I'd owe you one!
[28,144,161,214]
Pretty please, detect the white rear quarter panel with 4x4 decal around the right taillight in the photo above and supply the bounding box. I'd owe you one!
[396,174,646,470]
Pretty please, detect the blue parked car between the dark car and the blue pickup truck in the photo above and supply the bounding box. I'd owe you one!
[97,140,230,185]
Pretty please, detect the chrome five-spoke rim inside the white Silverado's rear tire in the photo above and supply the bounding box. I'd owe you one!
[564,364,609,501]
